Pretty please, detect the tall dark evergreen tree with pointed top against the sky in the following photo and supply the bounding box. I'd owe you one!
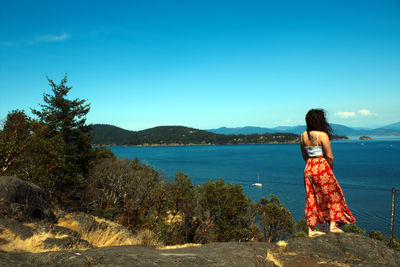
[32,76,94,189]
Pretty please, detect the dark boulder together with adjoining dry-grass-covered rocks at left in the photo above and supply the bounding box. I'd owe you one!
[0,176,138,252]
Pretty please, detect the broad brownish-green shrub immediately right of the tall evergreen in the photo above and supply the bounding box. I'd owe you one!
[88,158,167,231]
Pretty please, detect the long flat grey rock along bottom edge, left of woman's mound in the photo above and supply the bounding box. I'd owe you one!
[0,242,274,266]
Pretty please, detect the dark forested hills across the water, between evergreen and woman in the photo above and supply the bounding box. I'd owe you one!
[91,124,299,145]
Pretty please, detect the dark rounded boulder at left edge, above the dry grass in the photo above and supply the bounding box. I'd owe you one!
[0,176,55,222]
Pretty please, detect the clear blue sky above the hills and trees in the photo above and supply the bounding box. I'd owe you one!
[0,0,400,130]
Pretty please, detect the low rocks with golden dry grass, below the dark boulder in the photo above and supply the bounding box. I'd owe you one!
[0,212,153,254]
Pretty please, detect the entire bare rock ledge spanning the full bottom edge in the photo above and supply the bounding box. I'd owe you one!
[0,234,400,267]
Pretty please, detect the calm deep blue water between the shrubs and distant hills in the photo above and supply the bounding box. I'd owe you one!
[110,139,400,235]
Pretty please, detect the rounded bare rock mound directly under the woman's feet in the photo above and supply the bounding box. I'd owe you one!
[267,233,400,266]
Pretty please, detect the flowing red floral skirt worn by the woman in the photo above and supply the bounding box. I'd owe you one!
[304,157,356,227]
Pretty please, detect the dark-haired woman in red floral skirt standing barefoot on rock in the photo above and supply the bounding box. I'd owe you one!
[300,109,356,237]
